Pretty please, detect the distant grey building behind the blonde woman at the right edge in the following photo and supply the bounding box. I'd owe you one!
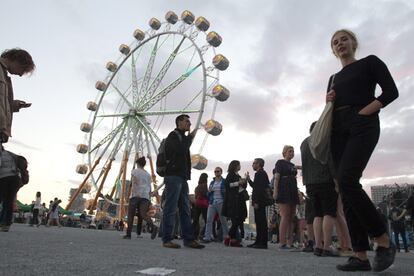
[371,183,414,204]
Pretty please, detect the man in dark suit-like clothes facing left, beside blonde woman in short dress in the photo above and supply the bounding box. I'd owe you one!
[247,158,270,249]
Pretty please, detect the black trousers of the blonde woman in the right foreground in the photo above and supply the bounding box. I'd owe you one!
[331,107,386,252]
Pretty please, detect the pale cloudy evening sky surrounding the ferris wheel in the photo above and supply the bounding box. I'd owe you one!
[0,0,414,206]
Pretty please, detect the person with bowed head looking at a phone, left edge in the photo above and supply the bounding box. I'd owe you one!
[0,48,36,143]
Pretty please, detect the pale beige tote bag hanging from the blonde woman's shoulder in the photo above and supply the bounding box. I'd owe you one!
[309,75,335,164]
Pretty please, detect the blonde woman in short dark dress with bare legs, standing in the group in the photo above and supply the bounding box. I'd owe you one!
[273,145,301,250]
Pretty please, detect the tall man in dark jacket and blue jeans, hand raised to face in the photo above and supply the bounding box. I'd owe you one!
[162,114,204,249]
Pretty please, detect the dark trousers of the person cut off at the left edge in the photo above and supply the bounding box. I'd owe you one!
[0,175,20,225]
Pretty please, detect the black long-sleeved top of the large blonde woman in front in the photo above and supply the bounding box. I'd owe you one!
[328,55,398,108]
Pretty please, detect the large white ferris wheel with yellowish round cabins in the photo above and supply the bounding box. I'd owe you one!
[67,10,230,217]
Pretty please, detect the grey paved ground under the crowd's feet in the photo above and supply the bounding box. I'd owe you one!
[0,224,414,276]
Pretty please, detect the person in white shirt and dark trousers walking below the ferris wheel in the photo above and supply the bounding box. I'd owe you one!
[123,157,158,239]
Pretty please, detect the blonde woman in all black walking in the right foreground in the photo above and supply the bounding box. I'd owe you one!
[326,29,398,272]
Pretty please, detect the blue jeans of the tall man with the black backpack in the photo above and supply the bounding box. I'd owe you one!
[162,176,194,243]
